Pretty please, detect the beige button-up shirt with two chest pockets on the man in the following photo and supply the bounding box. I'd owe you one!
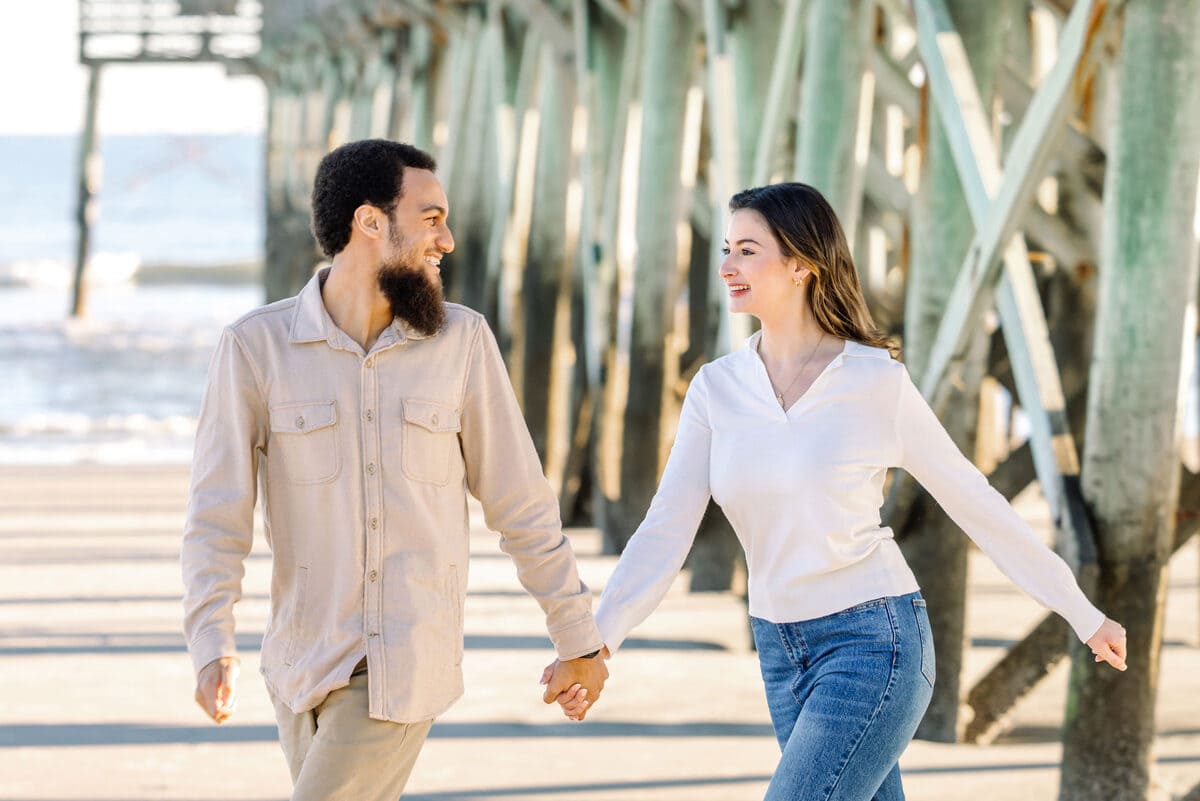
[181,267,602,722]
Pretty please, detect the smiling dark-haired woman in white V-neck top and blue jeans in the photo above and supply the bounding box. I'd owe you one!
[544,183,1126,801]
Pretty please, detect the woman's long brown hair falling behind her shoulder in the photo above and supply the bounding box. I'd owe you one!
[730,182,899,357]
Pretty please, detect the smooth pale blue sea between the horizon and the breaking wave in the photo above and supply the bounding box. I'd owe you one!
[0,134,264,273]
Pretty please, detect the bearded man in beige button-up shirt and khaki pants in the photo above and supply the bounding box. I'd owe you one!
[181,140,607,801]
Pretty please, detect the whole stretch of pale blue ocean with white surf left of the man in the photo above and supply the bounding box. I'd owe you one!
[0,135,263,464]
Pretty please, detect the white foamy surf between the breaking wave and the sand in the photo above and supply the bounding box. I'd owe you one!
[0,284,263,464]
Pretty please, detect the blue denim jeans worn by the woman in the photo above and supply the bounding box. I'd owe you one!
[750,592,934,801]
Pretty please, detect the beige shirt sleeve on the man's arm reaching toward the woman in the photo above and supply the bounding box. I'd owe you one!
[460,320,602,660]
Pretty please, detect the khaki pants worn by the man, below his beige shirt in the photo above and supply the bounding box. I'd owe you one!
[271,671,433,801]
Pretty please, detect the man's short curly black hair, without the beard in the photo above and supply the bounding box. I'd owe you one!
[312,139,438,258]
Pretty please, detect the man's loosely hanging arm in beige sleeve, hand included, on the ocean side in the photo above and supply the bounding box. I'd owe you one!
[180,329,266,723]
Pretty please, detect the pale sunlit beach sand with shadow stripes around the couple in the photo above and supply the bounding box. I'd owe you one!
[0,465,1200,801]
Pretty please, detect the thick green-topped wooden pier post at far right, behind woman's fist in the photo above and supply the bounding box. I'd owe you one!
[1058,0,1200,801]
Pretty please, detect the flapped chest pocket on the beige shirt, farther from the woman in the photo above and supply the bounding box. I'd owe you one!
[270,401,341,484]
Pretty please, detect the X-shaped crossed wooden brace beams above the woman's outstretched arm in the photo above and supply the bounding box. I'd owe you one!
[914,0,1111,565]
